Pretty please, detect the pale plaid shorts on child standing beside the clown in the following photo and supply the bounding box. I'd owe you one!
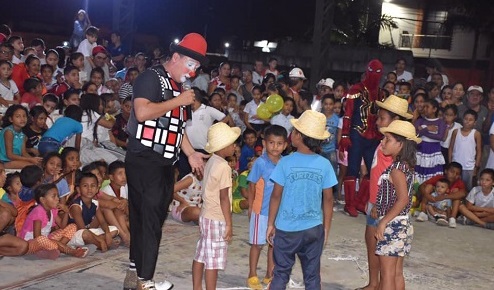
[194,216,228,270]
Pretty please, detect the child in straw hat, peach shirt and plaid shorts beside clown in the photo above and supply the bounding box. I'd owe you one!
[192,122,240,289]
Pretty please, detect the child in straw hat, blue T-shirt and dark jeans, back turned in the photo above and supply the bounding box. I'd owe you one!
[266,110,337,289]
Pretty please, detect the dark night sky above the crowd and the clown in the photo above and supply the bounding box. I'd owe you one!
[0,0,315,50]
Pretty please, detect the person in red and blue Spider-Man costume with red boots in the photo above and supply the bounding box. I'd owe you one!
[338,59,386,217]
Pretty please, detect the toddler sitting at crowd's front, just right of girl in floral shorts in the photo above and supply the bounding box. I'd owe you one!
[426,178,451,226]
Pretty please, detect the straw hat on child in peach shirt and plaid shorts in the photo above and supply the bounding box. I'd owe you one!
[204,122,240,153]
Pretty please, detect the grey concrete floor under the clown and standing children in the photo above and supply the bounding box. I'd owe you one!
[0,212,494,290]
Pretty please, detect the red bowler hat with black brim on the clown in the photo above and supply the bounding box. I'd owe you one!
[170,33,208,64]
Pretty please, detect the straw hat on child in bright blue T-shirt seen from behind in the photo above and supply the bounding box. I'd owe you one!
[290,110,331,140]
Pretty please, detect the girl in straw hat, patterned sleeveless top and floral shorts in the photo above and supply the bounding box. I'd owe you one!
[375,120,422,289]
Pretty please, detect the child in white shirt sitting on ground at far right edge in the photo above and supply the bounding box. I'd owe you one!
[460,168,494,230]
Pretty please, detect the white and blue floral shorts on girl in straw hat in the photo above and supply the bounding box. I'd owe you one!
[376,216,413,257]
